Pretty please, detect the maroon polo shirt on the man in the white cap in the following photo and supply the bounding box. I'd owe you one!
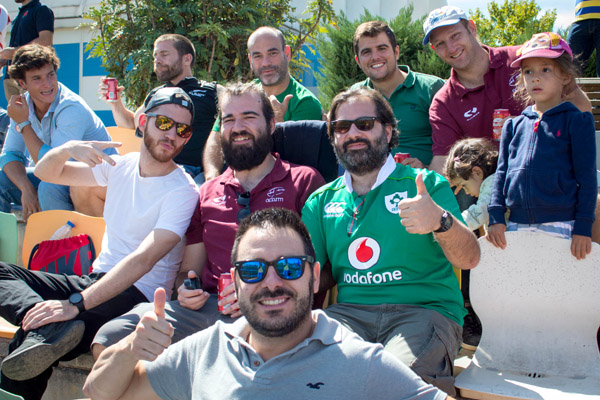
[429,46,525,156]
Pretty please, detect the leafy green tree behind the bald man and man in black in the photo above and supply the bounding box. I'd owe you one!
[84,0,335,106]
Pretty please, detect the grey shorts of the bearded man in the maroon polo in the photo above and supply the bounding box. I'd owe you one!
[92,294,235,347]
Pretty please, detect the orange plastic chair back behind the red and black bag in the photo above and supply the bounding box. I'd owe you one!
[22,210,106,267]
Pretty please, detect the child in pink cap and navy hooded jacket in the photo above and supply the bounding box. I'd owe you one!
[487,32,597,260]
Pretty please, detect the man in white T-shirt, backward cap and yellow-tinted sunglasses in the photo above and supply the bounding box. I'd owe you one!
[0,88,198,400]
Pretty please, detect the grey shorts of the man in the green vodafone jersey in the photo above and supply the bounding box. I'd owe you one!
[325,303,462,396]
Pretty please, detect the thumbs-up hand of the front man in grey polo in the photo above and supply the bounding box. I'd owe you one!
[130,288,173,361]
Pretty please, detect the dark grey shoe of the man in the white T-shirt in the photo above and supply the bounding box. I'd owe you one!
[2,320,85,381]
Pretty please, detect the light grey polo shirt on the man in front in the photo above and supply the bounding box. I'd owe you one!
[145,310,446,400]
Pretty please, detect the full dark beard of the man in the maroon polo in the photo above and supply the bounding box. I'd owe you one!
[221,129,273,171]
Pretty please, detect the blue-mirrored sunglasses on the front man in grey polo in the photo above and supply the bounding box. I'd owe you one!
[233,256,315,283]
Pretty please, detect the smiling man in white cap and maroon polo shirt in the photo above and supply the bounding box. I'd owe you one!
[423,6,591,173]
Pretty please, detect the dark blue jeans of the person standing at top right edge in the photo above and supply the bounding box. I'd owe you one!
[567,19,600,76]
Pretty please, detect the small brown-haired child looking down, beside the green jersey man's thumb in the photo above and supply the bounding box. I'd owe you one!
[444,139,498,231]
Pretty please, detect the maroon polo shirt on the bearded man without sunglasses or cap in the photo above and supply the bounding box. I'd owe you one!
[186,153,325,293]
